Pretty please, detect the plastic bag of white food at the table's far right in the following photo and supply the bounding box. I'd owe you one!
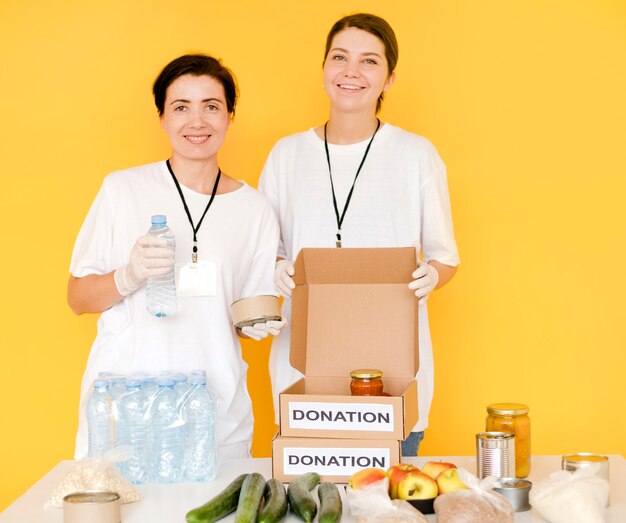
[530,464,609,523]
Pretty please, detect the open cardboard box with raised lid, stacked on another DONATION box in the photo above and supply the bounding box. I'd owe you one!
[279,247,419,440]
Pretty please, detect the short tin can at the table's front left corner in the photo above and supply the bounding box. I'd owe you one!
[63,490,122,523]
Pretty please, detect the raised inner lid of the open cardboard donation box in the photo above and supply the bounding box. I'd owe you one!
[290,247,419,381]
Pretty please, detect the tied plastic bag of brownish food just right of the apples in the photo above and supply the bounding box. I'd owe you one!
[435,468,515,523]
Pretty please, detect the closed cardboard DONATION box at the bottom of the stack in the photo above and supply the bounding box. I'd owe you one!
[272,435,400,483]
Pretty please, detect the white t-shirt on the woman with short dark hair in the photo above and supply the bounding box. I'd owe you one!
[70,162,279,458]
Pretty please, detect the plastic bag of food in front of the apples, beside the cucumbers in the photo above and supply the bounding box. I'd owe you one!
[346,478,428,523]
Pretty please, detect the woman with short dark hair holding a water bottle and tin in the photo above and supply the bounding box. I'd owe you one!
[68,54,285,458]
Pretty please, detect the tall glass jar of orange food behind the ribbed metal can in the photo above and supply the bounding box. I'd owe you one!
[487,403,530,478]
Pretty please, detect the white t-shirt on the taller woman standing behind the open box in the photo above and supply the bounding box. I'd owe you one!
[259,124,459,430]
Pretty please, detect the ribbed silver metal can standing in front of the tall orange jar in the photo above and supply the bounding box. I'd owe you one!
[476,432,515,479]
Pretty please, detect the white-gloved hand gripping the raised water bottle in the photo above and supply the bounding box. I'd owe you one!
[113,236,174,296]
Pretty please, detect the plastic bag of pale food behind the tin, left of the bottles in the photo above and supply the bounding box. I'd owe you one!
[44,446,141,508]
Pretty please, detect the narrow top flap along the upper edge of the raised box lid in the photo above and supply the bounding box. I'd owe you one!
[293,247,417,285]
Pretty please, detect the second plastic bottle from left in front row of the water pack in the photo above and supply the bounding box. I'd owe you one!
[117,378,150,484]
